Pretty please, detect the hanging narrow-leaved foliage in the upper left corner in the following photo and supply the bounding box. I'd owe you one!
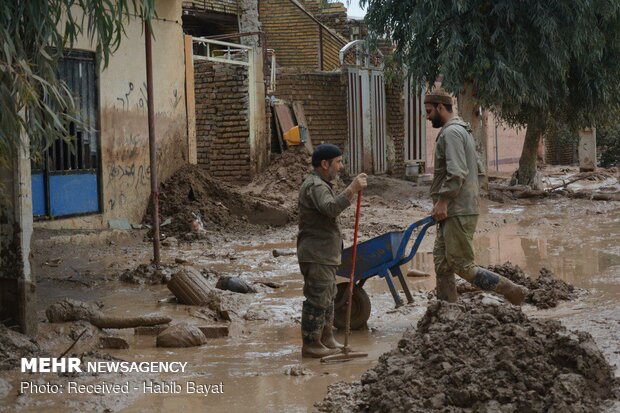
[0,0,155,161]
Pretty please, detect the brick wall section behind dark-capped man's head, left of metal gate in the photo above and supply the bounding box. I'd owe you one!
[275,72,348,149]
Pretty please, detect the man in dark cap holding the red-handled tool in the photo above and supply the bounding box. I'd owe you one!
[297,144,367,358]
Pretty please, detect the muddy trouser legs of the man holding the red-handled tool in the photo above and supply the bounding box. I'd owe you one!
[299,262,338,344]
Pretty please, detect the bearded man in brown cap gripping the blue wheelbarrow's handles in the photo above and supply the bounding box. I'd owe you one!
[424,89,528,305]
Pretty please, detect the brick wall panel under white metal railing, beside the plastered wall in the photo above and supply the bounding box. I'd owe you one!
[194,62,251,182]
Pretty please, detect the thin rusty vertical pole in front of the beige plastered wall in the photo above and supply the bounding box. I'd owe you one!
[144,21,160,267]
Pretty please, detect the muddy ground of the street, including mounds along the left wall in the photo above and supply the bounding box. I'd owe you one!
[0,162,620,412]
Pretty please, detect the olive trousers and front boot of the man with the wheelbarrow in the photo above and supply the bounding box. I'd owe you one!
[433,215,478,302]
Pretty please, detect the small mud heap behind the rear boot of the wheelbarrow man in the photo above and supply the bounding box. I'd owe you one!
[487,262,578,309]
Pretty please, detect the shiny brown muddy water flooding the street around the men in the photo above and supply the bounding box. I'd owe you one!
[0,196,620,412]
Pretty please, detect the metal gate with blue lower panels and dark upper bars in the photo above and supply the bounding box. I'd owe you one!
[32,52,101,217]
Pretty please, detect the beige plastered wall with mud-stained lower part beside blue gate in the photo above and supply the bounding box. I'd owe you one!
[36,0,187,229]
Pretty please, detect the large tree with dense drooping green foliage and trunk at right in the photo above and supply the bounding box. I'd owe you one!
[360,0,620,184]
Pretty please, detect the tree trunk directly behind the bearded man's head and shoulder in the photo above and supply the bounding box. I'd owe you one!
[458,83,489,189]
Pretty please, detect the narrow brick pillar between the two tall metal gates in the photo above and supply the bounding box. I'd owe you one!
[385,82,405,177]
